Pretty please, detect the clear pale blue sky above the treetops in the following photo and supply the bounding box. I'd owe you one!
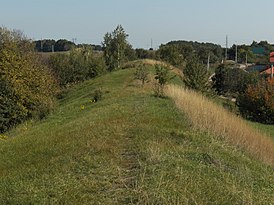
[0,0,274,48]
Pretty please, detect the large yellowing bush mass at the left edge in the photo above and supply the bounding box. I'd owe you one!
[0,28,58,132]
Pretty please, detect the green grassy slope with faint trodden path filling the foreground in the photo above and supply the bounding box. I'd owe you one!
[0,70,274,204]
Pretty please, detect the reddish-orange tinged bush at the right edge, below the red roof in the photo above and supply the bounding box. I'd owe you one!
[237,79,274,124]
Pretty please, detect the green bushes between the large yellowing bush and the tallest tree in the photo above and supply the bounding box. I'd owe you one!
[49,48,105,87]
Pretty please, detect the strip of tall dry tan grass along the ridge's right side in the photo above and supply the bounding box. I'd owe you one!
[165,85,274,165]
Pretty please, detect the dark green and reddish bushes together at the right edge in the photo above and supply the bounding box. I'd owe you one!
[213,62,274,124]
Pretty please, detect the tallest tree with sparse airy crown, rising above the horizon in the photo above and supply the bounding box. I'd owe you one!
[102,25,132,71]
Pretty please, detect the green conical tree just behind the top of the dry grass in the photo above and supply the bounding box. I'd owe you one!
[183,57,211,93]
